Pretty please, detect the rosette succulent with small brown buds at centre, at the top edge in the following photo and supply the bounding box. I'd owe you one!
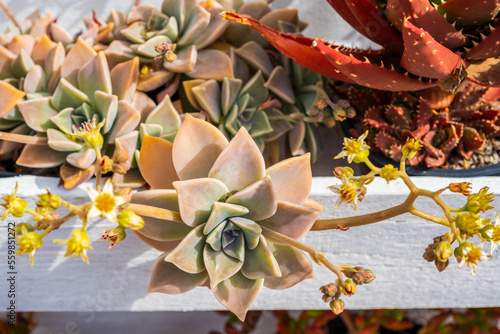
[105,0,233,94]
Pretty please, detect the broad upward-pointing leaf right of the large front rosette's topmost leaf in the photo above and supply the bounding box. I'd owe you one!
[208,128,265,191]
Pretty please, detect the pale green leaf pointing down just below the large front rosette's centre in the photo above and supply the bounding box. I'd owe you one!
[203,244,243,288]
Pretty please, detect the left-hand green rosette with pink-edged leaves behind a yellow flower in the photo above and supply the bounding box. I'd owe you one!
[12,39,145,187]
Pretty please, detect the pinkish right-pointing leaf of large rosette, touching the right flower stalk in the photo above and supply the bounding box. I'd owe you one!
[259,201,321,239]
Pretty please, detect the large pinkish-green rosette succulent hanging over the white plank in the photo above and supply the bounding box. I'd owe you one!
[132,114,321,319]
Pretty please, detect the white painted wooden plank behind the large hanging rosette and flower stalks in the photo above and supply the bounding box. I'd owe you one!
[0,176,500,312]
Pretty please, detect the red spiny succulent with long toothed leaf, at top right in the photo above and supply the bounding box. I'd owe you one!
[225,0,500,91]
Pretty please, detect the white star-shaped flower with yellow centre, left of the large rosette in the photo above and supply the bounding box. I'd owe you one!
[87,179,128,224]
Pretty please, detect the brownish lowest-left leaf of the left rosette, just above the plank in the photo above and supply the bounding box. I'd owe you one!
[16,145,66,168]
